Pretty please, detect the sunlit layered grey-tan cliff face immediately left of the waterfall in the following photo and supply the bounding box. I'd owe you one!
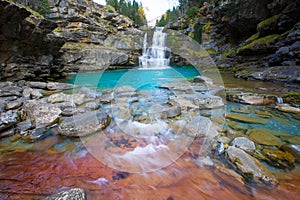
[47,0,143,72]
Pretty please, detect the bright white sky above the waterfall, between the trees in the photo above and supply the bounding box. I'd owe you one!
[93,0,178,25]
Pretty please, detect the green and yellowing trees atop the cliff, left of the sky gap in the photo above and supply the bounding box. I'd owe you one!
[106,0,147,26]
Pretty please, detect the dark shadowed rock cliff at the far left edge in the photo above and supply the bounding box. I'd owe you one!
[0,1,64,80]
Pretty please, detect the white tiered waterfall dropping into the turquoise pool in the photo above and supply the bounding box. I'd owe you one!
[139,27,170,69]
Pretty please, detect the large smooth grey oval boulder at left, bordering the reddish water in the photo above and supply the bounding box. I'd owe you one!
[58,111,110,137]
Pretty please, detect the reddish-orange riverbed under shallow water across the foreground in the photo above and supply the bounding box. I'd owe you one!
[0,137,300,200]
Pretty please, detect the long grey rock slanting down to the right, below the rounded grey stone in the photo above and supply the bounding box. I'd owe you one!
[226,146,278,186]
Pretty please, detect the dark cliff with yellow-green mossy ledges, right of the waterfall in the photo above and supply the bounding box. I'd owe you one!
[167,0,300,84]
